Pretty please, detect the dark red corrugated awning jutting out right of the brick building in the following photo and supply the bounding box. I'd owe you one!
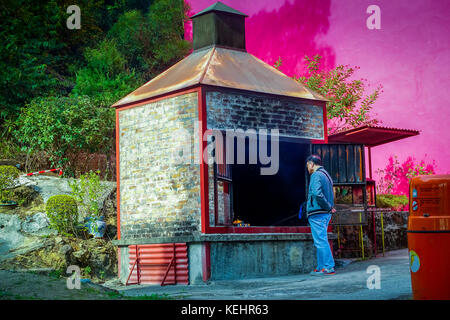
[328,125,419,147]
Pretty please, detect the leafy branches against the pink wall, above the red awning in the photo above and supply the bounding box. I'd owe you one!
[290,55,382,134]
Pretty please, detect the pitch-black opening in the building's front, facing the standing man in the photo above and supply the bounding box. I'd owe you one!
[230,140,310,227]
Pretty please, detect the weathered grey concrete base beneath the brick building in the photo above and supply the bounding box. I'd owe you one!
[117,233,335,284]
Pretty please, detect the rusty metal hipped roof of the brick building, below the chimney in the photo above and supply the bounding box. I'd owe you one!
[113,46,327,107]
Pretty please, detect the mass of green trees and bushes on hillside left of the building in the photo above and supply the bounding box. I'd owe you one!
[0,0,191,175]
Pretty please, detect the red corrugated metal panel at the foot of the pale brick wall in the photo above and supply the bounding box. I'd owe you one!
[127,243,189,285]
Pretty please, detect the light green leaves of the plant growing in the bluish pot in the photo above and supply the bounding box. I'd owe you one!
[69,171,102,218]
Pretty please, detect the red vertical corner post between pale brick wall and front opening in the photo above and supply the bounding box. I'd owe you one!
[197,87,209,233]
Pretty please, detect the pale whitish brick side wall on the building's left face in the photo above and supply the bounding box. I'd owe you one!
[119,92,201,239]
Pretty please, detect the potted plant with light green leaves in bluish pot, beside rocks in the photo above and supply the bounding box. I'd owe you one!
[69,171,106,238]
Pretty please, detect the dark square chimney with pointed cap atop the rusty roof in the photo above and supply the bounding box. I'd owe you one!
[191,1,248,50]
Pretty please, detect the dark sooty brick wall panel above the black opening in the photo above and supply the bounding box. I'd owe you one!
[206,90,324,139]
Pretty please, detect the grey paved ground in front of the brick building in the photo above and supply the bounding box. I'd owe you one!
[107,249,412,300]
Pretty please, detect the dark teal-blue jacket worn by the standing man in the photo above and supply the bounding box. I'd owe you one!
[306,167,334,217]
